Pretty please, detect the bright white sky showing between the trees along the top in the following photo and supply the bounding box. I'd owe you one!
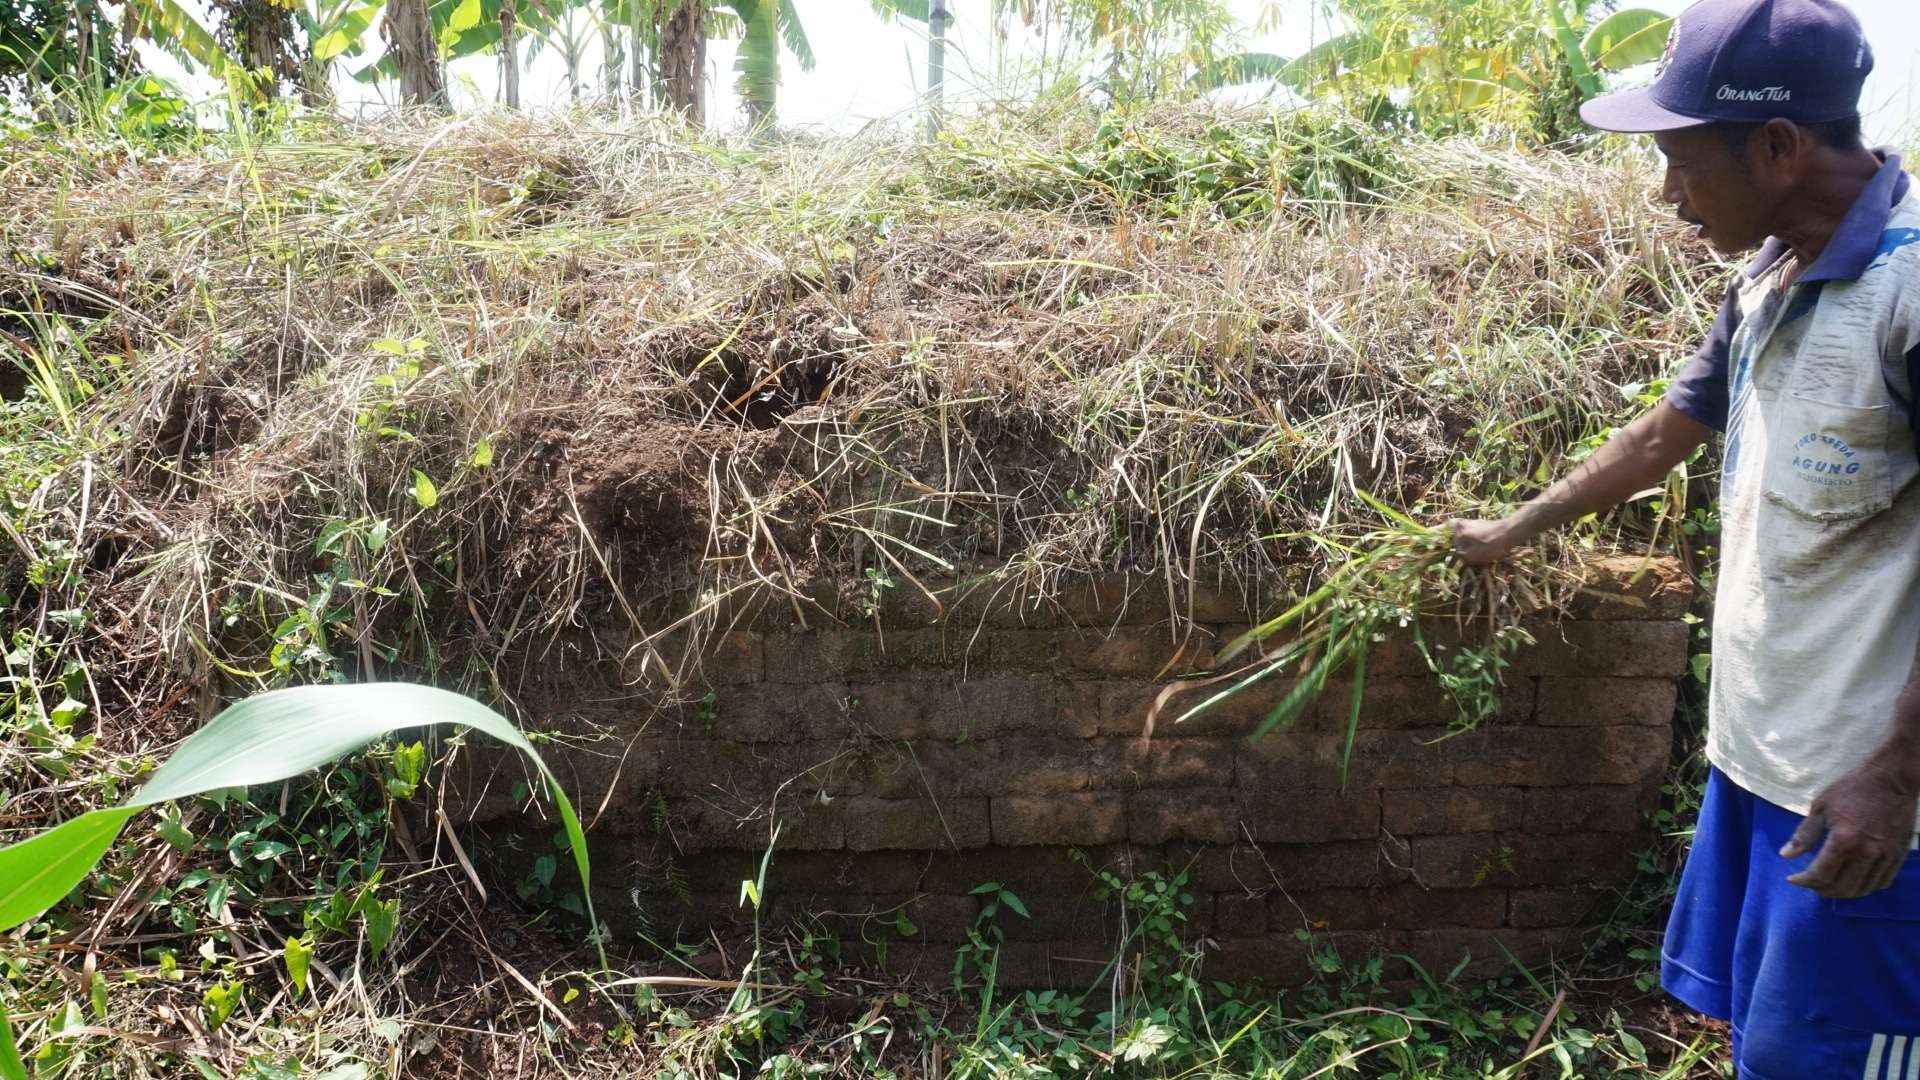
[150,0,1920,142]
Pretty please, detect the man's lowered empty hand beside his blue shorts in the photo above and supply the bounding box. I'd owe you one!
[1780,761,1920,899]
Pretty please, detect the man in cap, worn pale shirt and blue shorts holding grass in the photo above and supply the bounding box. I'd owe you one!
[1453,0,1920,1080]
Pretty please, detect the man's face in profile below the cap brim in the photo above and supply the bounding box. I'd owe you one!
[1653,127,1778,256]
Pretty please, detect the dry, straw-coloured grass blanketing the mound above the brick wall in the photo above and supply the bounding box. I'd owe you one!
[0,98,1713,1068]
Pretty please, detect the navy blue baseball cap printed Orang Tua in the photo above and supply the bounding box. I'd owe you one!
[1580,0,1874,133]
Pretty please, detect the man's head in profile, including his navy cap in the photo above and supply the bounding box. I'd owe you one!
[1580,0,1874,252]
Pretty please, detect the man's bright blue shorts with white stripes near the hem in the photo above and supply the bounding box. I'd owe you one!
[1661,769,1920,1080]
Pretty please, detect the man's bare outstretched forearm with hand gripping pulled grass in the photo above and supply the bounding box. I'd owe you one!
[1453,400,1713,565]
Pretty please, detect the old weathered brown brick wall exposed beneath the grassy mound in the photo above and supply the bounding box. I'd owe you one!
[478,559,1690,984]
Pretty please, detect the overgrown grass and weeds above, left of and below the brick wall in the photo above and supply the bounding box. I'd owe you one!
[0,94,1751,1078]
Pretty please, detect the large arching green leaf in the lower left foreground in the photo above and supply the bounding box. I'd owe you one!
[0,682,605,1080]
